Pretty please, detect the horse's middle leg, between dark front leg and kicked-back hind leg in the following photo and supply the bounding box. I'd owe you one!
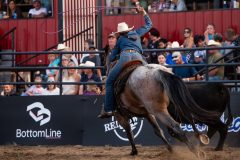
[146,114,172,152]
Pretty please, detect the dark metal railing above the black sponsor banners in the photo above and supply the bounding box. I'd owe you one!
[0,46,240,95]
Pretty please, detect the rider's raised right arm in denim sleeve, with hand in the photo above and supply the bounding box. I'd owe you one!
[136,9,152,37]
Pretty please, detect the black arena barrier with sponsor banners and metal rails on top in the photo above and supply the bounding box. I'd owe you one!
[0,46,240,147]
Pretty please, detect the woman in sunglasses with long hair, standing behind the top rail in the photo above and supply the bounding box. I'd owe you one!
[182,28,194,63]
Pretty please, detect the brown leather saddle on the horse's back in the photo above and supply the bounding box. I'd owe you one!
[114,60,143,108]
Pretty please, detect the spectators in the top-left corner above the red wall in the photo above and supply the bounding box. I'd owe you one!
[0,0,52,19]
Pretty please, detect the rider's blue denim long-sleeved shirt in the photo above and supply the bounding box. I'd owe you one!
[109,14,152,62]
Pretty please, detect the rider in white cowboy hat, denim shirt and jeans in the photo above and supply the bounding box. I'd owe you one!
[98,5,152,118]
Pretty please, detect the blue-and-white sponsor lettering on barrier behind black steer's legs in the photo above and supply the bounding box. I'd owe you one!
[180,114,240,133]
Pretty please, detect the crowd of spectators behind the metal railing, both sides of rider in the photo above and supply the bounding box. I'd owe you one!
[1,24,240,96]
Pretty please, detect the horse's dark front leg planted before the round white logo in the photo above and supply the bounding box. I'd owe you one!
[114,113,138,155]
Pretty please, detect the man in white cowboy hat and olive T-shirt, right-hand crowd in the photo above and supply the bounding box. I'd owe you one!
[205,40,224,80]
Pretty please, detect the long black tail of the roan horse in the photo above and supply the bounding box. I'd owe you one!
[155,70,220,124]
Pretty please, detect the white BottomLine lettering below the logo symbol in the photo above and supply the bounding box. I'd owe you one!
[16,129,62,139]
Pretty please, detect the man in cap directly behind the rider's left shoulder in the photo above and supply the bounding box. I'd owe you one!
[100,33,117,75]
